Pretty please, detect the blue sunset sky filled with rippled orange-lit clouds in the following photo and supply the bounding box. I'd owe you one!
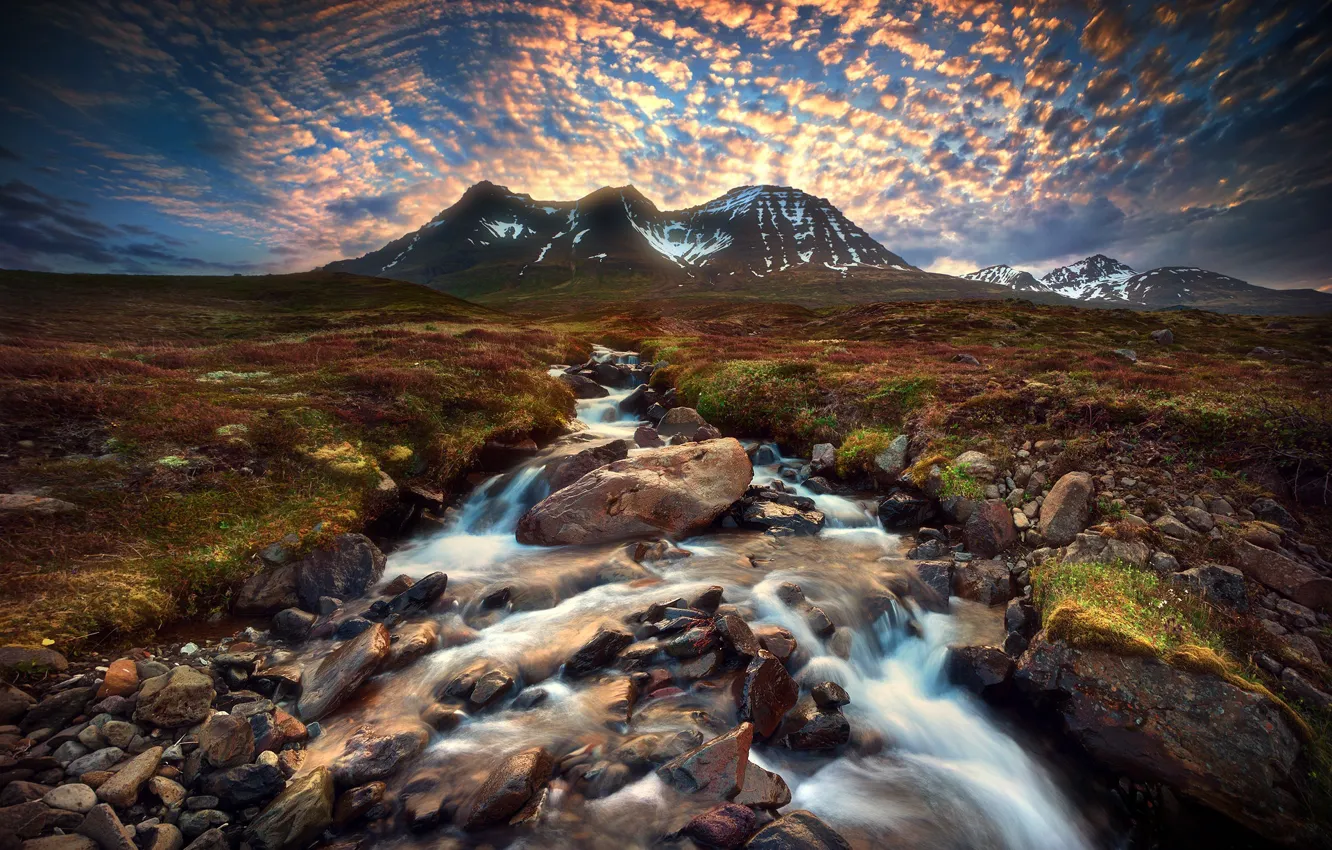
[0,0,1332,290]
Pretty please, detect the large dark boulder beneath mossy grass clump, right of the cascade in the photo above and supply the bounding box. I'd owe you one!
[1014,634,1307,843]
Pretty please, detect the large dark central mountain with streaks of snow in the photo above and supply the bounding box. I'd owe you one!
[328,181,916,282]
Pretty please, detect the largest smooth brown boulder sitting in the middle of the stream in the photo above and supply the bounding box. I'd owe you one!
[518,438,754,545]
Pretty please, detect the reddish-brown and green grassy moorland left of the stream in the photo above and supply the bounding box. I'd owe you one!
[0,272,587,649]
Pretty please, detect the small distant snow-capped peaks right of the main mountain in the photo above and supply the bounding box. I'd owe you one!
[962,254,1272,309]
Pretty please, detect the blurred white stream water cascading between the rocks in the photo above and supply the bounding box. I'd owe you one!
[312,349,1094,850]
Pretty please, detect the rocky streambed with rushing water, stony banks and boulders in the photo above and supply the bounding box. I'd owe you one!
[0,350,1332,850]
